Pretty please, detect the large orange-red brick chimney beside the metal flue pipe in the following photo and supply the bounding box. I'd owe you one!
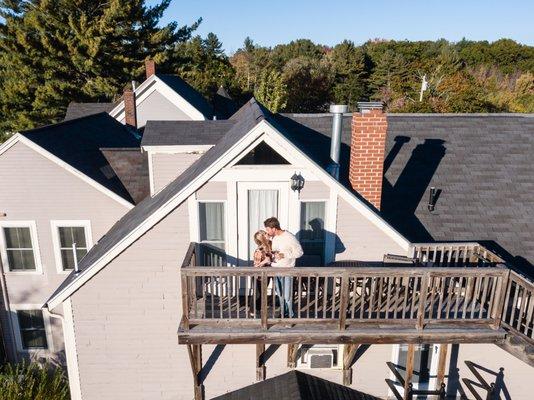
[349,102,388,210]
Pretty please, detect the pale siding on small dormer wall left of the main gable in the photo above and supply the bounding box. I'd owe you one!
[151,153,202,193]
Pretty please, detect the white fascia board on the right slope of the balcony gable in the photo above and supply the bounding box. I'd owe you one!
[265,122,411,251]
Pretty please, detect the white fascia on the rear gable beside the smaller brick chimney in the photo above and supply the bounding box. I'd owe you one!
[109,75,206,121]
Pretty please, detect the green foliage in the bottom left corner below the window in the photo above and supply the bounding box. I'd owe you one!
[0,363,70,400]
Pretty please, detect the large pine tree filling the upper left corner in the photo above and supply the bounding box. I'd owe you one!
[0,0,200,132]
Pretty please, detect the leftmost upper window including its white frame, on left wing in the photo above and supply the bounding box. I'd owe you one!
[0,222,40,272]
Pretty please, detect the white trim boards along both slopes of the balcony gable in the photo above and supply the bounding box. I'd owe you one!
[48,120,410,309]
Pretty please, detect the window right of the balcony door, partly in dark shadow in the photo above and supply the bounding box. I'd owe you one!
[299,201,326,265]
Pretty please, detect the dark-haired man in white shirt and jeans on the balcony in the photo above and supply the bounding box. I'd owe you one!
[263,217,304,318]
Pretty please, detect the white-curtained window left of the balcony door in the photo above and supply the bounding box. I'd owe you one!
[198,202,226,250]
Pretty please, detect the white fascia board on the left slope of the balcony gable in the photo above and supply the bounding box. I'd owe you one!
[47,121,268,310]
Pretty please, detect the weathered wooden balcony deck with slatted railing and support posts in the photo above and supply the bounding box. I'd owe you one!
[178,243,534,399]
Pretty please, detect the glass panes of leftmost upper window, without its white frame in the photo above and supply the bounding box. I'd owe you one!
[3,227,36,271]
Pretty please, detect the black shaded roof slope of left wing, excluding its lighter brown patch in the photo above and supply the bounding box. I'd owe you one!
[21,113,139,202]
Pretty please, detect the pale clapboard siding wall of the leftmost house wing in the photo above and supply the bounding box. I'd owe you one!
[0,142,128,358]
